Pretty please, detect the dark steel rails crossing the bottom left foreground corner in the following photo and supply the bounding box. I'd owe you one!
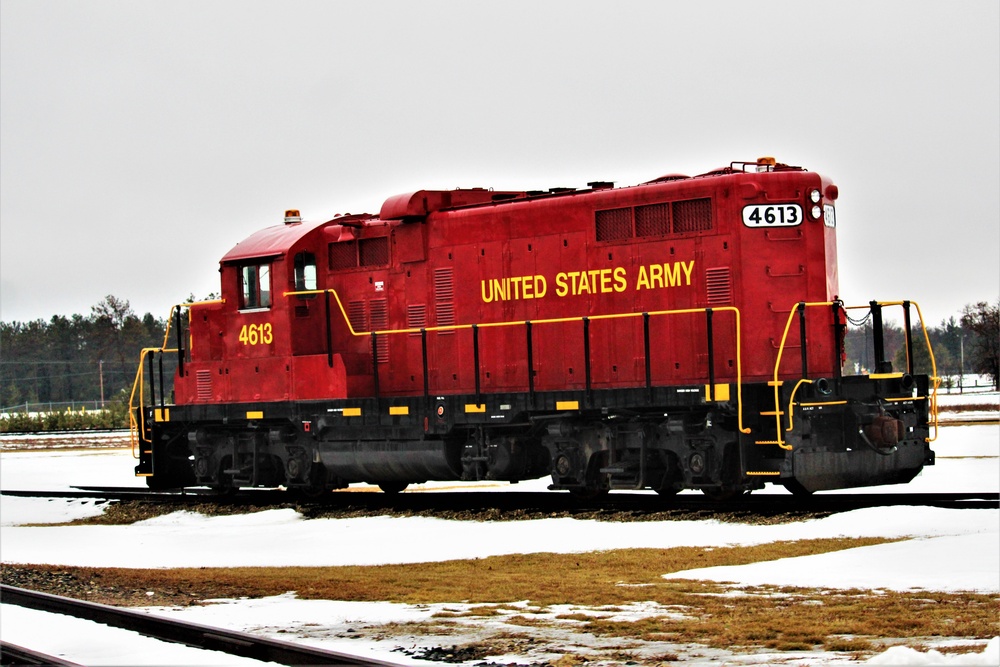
[0,585,397,667]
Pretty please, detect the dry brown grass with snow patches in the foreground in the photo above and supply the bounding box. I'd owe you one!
[4,538,1000,656]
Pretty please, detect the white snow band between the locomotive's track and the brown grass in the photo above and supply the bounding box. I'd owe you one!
[0,507,1000,591]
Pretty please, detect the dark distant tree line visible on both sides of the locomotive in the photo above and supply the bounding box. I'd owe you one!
[0,295,1000,410]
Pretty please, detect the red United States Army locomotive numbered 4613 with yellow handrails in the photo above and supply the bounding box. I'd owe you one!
[134,158,936,497]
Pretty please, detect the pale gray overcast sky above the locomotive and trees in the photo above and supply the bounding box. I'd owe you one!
[0,0,1000,324]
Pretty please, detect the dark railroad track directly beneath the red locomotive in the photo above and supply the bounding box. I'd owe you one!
[0,487,1000,519]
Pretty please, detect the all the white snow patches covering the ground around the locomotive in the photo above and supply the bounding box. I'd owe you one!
[0,414,1000,665]
